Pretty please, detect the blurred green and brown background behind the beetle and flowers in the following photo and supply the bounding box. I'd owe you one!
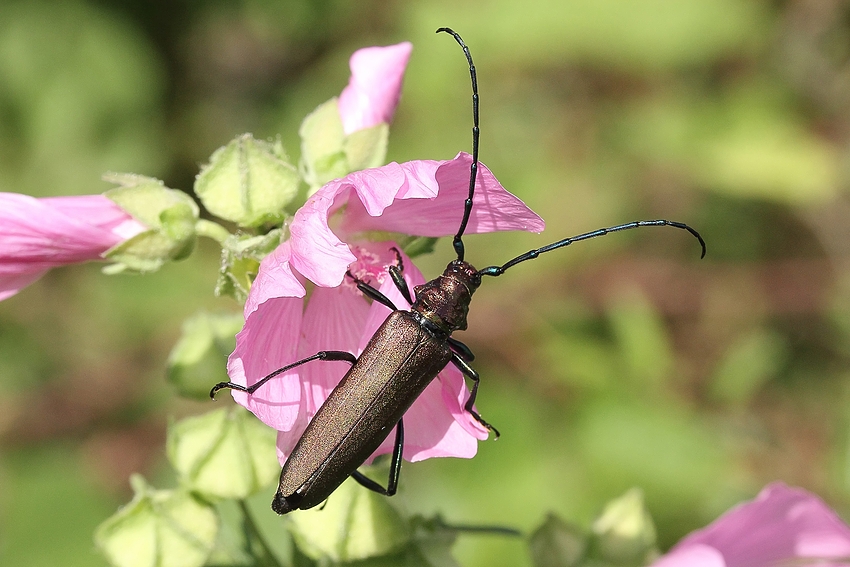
[0,0,850,566]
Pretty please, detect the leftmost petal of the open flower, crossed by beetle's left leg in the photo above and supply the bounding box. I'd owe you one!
[227,297,303,431]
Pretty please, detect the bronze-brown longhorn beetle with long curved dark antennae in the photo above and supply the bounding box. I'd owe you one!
[210,28,705,514]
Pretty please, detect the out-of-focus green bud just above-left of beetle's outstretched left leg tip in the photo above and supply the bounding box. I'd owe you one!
[167,312,245,400]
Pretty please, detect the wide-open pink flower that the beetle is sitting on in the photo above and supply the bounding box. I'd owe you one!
[228,153,544,462]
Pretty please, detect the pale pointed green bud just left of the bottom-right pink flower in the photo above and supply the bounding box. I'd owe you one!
[593,488,655,566]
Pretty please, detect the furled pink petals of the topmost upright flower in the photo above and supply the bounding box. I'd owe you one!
[338,42,413,135]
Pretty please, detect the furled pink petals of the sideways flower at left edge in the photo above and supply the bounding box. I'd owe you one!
[0,193,146,300]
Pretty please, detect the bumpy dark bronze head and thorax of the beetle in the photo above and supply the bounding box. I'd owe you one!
[411,260,481,335]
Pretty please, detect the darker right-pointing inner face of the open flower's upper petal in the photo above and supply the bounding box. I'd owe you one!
[344,152,545,236]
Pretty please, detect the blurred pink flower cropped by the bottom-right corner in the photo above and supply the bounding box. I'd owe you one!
[652,482,850,567]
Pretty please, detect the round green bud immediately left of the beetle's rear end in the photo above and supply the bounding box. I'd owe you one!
[166,406,280,499]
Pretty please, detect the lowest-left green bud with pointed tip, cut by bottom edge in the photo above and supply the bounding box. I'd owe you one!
[94,475,218,567]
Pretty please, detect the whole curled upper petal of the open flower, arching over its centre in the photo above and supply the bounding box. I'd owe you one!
[289,153,544,287]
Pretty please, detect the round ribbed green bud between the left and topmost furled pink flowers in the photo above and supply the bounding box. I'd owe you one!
[195,134,301,227]
